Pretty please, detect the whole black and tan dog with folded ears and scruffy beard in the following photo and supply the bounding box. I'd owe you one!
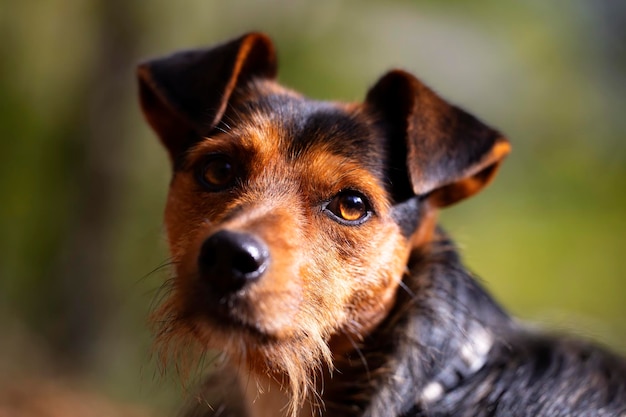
[138,33,626,417]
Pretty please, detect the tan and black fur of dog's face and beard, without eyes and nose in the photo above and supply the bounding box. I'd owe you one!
[153,79,409,414]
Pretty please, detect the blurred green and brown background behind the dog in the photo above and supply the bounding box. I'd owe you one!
[0,0,626,415]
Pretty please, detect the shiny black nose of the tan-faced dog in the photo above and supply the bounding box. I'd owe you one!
[198,230,270,296]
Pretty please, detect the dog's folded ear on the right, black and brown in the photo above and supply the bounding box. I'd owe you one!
[366,70,510,207]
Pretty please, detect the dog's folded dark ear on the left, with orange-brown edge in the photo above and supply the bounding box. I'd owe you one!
[137,33,277,162]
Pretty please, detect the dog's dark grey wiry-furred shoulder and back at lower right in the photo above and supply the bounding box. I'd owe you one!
[376,238,626,417]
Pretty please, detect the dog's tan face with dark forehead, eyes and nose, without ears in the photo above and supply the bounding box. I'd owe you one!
[161,81,408,347]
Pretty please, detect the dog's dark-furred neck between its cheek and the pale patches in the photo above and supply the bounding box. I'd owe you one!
[316,230,513,417]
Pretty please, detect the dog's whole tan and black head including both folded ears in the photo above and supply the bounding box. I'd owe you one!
[139,34,509,406]
